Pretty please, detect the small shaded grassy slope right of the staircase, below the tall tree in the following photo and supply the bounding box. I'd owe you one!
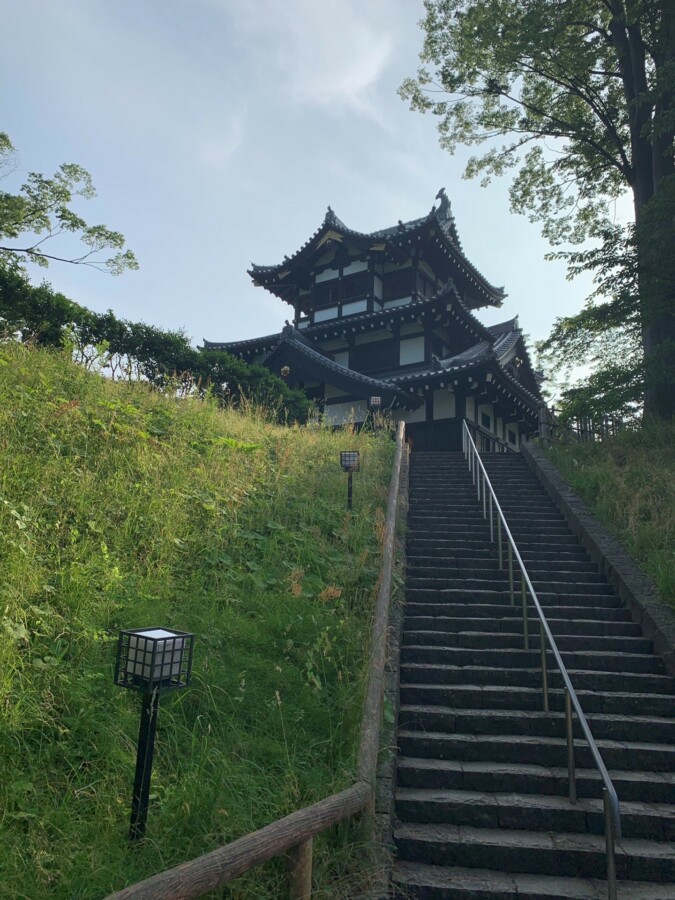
[548,423,675,604]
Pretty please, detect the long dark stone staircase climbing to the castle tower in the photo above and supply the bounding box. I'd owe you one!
[392,453,675,900]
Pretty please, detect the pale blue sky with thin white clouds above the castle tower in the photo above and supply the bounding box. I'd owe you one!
[0,0,608,352]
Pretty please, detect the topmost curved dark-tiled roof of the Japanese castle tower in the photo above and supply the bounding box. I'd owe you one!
[249,188,506,306]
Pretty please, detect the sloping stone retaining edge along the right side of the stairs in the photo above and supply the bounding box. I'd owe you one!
[521,443,675,677]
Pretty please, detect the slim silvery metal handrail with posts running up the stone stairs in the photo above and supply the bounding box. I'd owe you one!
[462,420,621,900]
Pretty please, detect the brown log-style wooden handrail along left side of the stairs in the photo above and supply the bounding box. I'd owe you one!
[107,422,405,900]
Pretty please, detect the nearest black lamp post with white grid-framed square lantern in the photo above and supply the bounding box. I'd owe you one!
[115,628,195,841]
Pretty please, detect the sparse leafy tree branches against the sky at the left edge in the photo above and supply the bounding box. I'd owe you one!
[0,132,138,275]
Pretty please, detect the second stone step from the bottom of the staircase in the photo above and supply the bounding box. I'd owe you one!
[394,824,675,883]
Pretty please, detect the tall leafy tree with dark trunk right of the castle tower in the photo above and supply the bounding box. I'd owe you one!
[401,0,675,418]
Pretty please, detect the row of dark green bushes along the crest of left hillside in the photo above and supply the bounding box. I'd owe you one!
[0,265,310,422]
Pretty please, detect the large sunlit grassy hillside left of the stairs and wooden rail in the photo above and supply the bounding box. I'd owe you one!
[0,344,394,900]
